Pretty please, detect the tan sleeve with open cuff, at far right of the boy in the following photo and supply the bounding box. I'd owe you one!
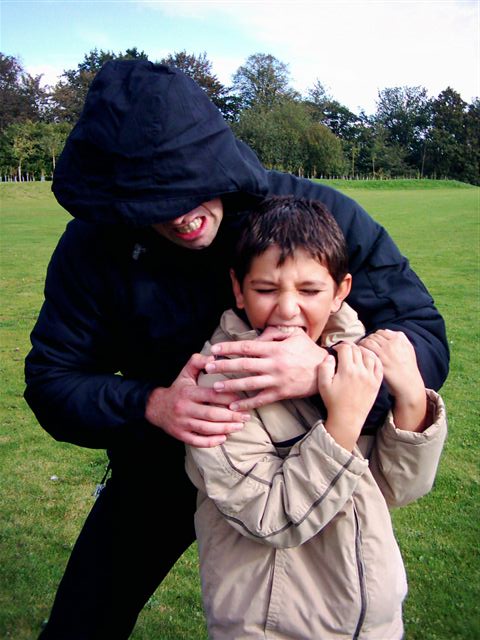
[370,390,447,507]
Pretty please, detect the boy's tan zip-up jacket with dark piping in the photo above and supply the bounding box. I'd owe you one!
[186,305,446,640]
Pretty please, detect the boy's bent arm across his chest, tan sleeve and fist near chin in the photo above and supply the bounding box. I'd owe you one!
[187,345,380,547]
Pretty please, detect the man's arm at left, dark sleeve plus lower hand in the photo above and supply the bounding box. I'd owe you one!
[25,222,246,448]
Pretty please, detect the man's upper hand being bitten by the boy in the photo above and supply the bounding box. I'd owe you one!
[205,328,327,411]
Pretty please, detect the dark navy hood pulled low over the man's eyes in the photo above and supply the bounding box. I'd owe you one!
[52,60,268,226]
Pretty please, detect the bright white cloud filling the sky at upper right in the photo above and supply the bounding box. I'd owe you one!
[140,0,479,111]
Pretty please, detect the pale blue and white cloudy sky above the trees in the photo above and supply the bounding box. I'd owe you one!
[0,0,480,114]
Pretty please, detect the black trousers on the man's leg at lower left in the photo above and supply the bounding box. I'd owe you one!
[40,448,196,640]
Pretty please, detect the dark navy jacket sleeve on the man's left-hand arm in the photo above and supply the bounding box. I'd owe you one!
[25,221,155,448]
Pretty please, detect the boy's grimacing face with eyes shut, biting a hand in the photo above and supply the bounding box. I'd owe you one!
[231,246,351,342]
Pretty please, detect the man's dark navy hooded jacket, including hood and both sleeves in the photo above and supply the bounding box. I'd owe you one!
[25,61,449,456]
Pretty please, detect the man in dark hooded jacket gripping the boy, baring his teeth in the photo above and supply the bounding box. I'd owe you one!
[25,61,448,640]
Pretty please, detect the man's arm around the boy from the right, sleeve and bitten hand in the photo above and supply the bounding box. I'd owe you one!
[208,172,449,410]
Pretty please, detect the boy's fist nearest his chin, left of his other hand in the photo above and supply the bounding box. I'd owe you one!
[318,343,383,451]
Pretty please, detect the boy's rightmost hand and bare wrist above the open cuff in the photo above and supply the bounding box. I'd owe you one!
[361,329,427,431]
